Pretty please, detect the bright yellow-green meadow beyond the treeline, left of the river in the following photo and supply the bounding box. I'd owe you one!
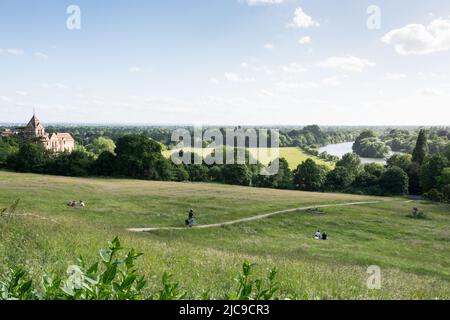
[162,147,334,170]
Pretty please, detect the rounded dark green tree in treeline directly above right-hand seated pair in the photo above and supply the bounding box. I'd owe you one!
[294,159,327,191]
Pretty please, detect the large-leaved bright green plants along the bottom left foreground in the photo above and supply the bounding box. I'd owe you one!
[0,237,278,300]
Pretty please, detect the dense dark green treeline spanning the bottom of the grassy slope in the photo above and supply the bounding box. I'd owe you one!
[0,126,450,202]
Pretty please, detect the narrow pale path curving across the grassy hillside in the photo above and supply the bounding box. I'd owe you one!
[127,201,380,232]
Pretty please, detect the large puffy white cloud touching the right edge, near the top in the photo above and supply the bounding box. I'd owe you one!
[381,18,450,55]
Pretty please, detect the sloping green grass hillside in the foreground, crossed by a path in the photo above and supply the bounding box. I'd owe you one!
[0,172,450,299]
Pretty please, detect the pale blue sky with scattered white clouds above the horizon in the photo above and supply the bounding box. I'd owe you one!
[0,0,450,125]
